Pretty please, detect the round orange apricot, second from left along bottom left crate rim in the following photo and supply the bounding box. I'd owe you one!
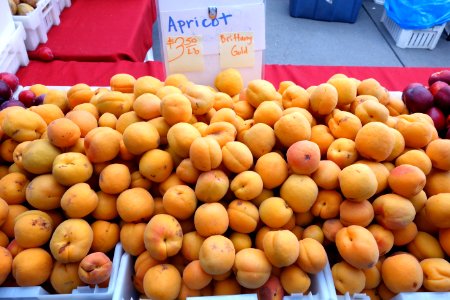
[12,248,53,286]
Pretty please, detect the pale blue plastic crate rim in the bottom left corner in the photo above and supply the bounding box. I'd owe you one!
[0,243,124,300]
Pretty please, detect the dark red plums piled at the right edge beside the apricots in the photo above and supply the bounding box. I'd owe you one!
[402,70,450,139]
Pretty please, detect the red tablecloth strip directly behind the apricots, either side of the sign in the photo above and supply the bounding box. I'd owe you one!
[17,59,445,91]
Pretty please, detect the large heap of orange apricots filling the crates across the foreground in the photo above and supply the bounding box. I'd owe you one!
[0,69,450,299]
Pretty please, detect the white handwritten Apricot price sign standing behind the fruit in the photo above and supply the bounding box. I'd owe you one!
[158,0,265,85]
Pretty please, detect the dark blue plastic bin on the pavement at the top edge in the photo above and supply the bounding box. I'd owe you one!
[289,0,362,23]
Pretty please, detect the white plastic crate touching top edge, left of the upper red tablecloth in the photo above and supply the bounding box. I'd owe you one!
[13,0,60,51]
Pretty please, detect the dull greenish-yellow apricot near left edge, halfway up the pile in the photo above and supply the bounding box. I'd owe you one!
[22,139,61,174]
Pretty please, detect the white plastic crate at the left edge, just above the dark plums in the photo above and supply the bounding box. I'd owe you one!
[0,22,29,74]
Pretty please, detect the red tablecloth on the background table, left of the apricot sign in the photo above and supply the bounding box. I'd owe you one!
[29,0,156,62]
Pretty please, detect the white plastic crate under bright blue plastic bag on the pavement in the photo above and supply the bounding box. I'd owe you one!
[381,10,445,50]
